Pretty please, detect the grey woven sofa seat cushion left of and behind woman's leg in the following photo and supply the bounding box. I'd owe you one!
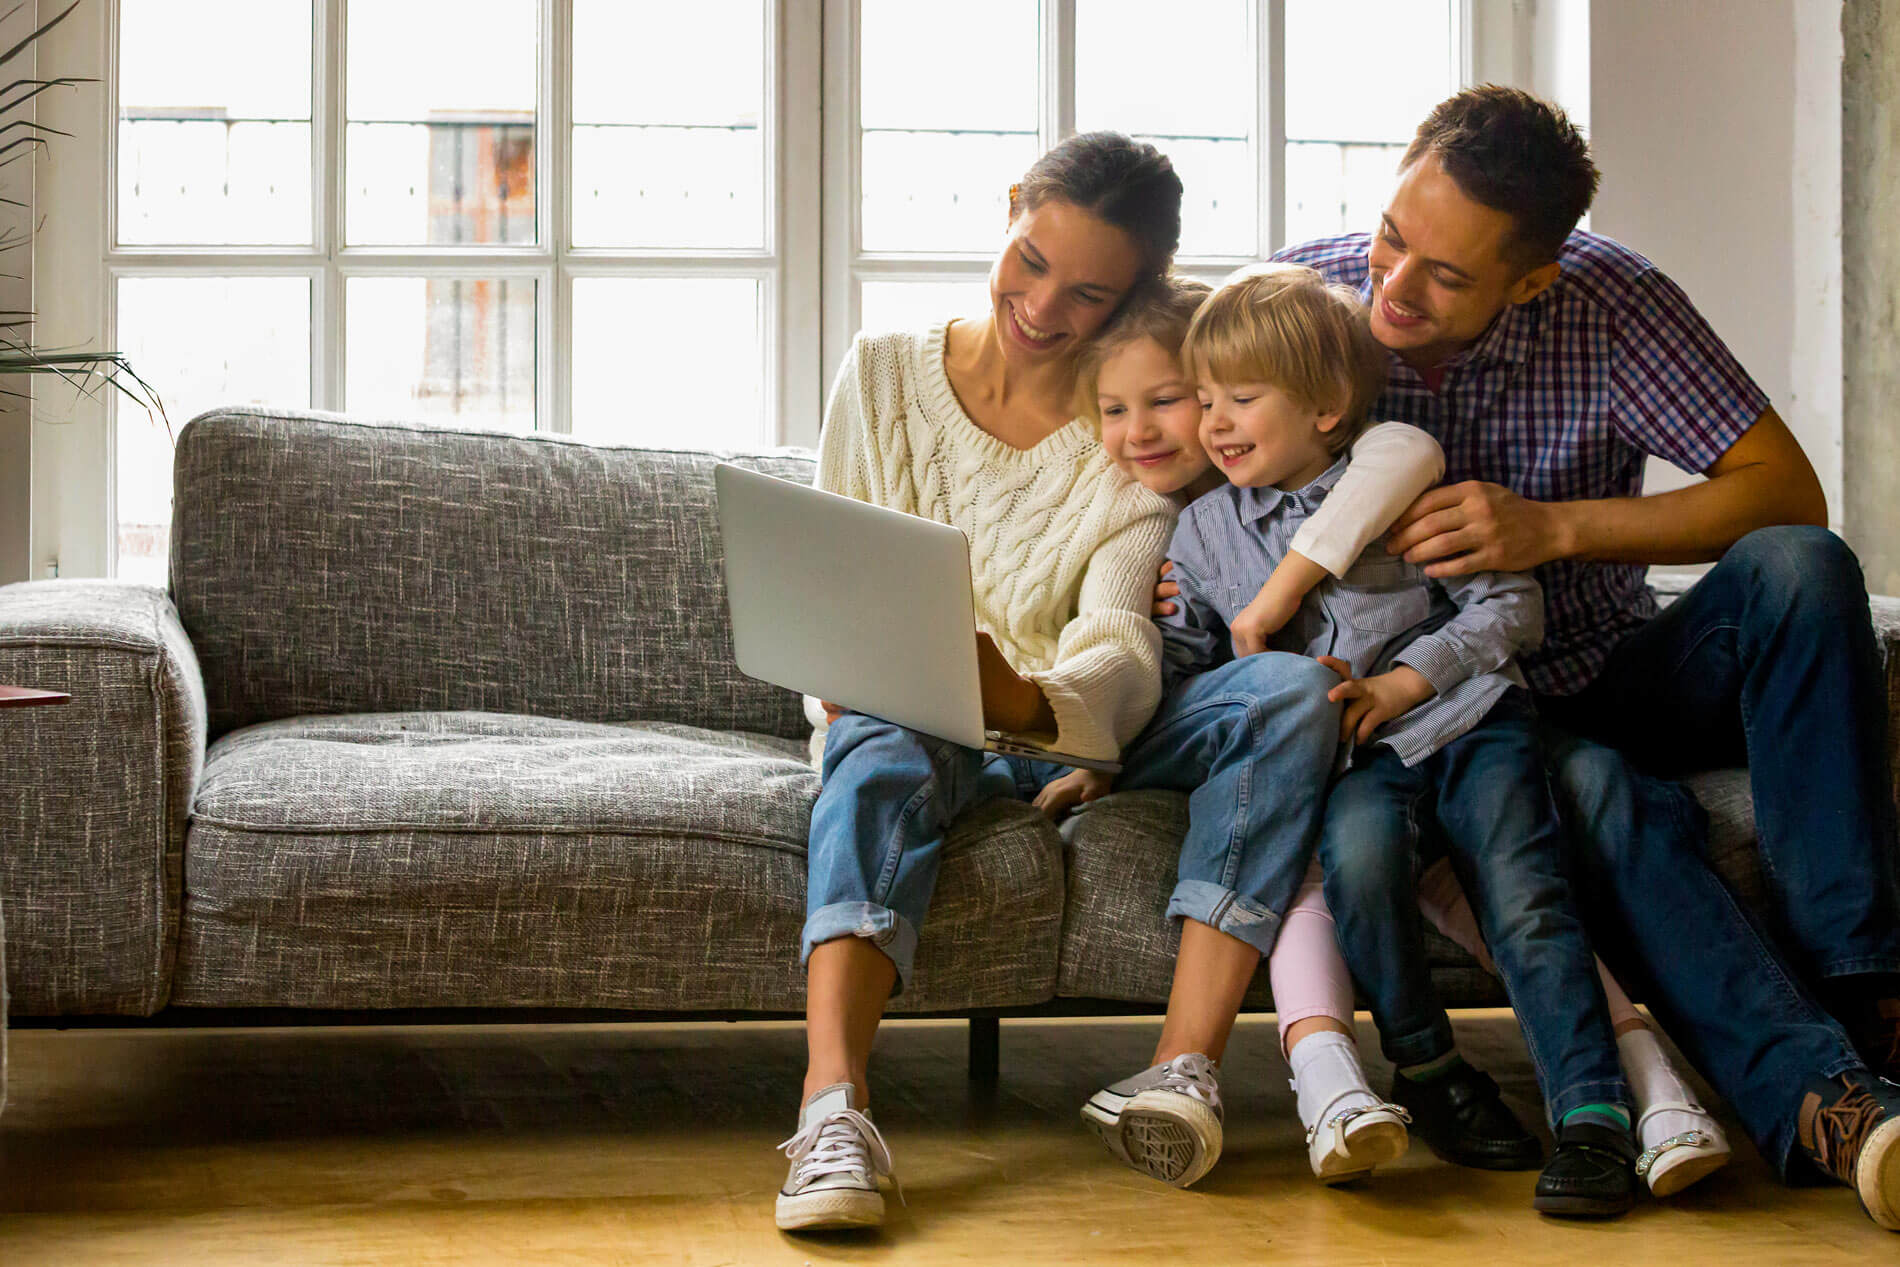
[173,712,1062,1011]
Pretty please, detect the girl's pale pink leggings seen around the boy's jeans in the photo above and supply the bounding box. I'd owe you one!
[1267,859,1640,1052]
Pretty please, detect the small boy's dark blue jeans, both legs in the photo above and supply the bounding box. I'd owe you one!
[1319,690,1630,1126]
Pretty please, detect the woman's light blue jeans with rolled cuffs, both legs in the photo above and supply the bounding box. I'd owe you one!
[804,652,1340,990]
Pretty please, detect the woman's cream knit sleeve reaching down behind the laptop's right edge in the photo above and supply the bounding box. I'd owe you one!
[1026,509,1174,760]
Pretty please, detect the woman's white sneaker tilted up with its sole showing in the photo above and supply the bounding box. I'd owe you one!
[1081,1052,1220,1187]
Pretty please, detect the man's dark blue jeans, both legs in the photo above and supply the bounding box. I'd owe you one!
[1539,528,1900,1178]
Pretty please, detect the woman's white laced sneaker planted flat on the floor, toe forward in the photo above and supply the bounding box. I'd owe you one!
[779,1083,895,1231]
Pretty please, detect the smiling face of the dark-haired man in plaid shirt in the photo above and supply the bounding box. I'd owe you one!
[1368,154,1556,369]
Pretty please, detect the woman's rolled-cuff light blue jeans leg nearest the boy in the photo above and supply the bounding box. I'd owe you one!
[1115,652,1340,955]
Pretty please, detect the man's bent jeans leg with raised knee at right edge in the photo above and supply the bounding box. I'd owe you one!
[1539,528,1900,982]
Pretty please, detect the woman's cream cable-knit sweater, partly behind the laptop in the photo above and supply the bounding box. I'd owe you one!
[806,323,1174,762]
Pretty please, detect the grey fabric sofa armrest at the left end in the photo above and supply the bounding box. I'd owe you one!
[0,581,205,1016]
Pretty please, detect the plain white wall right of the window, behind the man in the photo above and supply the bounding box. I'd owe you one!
[1588,0,1841,528]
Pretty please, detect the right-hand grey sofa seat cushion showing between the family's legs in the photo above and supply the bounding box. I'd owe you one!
[1056,769,1765,1009]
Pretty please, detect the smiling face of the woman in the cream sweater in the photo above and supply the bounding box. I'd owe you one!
[990,199,1142,365]
